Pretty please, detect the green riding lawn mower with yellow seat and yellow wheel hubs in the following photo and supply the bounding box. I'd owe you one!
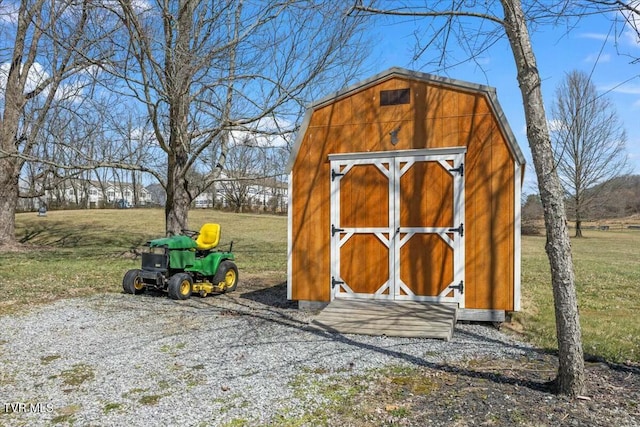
[122,223,238,299]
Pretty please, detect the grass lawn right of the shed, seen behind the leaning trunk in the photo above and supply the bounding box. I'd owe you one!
[514,230,640,362]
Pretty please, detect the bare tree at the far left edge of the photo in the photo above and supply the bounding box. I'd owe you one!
[0,0,120,246]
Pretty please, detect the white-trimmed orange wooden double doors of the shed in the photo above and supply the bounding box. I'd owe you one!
[331,149,464,307]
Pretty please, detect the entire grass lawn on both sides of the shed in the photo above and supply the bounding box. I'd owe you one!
[0,209,640,363]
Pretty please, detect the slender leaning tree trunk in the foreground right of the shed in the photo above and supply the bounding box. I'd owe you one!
[502,0,584,396]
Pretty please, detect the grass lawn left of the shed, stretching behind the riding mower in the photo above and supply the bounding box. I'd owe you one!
[0,209,287,315]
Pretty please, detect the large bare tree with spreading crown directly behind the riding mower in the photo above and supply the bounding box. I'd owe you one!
[105,0,362,233]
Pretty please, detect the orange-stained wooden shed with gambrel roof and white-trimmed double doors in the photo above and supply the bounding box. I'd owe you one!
[288,68,525,321]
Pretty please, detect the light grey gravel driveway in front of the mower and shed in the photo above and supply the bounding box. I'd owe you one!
[0,285,534,426]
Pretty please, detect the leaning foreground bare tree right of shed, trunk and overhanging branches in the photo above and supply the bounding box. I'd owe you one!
[353,0,584,396]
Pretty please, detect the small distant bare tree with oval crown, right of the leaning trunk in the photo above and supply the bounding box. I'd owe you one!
[551,71,627,237]
